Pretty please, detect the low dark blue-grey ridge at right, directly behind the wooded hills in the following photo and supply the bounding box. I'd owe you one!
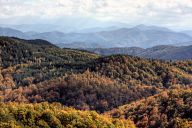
[86,45,192,60]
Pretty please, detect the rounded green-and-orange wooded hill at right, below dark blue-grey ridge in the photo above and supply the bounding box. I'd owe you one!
[90,55,192,88]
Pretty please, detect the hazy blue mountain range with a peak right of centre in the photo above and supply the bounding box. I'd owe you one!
[0,25,192,48]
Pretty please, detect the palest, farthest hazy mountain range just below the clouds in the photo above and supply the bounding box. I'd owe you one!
[0,16,130,33]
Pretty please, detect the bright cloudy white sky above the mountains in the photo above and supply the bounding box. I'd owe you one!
[0,0,192,29]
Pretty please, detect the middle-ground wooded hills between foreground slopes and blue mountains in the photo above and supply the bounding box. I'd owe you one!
[0,37,192,113]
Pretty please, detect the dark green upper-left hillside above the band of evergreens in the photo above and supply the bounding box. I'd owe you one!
[0,37,98,67]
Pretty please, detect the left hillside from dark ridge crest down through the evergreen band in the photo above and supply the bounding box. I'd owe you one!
[0,37,99,86]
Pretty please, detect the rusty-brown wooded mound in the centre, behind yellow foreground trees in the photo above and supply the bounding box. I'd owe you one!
[0,71,160,112]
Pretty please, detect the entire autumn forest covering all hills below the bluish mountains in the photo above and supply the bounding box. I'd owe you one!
[0,37,192,128]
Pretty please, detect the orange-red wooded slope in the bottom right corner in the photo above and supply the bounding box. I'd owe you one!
[107,89,192,128]
